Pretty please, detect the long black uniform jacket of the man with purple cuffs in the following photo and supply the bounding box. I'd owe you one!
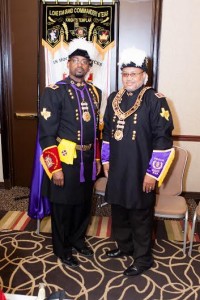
[103,87,173,209]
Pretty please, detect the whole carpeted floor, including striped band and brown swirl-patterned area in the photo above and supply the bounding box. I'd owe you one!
[0,188,200,300]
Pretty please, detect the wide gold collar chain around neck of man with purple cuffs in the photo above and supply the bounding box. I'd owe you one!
[112,86,151,120]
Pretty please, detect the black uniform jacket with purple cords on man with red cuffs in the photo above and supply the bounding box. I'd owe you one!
[39,77,101,204]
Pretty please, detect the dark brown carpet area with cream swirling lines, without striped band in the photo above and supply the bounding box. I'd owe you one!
[0,230,200,300]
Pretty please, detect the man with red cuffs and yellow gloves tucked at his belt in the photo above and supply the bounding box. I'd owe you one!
[39,39,101,267]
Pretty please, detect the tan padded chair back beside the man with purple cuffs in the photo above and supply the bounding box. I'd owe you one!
[156,146,188,196]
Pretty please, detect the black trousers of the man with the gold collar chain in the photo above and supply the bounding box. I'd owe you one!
[111,204,154,267]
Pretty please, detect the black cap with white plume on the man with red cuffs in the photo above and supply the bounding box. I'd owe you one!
[68,38,96,61]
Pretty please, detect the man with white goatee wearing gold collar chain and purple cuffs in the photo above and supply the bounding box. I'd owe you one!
[101,47,174,276]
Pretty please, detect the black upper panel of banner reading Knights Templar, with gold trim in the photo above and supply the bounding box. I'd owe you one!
[42,4,115,55]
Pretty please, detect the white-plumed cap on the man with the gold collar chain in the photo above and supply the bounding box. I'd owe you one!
[118,47,148,72]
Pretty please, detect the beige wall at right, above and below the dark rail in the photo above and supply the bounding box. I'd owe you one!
[158,0,200,192]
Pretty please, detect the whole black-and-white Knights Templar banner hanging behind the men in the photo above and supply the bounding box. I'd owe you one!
[42,4,115,123]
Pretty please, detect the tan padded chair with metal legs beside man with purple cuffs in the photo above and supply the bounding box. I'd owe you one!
[155,146,188,254]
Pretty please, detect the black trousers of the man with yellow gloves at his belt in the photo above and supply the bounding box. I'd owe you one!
[51,188,92,258]
